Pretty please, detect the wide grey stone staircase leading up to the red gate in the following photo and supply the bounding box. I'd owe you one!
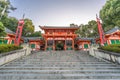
[0,51,120,80]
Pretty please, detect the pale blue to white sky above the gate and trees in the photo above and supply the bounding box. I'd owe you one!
[9,0,106,31]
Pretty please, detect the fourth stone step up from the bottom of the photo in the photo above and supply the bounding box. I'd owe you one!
[4,63,116,67]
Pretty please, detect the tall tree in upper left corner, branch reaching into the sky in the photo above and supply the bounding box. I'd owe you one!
[0,0,18,32]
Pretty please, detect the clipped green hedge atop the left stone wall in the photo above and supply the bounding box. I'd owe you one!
[0,44,23,53]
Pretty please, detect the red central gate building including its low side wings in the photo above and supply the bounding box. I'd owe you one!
[27,26,91,50]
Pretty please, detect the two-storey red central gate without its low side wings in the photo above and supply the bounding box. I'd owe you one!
[40,26,79,50]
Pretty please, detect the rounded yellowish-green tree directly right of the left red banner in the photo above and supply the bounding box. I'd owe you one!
[22,18,34,36]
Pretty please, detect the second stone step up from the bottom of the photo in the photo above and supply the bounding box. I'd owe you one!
[0,70,120,75]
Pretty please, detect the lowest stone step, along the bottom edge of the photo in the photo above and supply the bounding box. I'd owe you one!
[0,74,120,80]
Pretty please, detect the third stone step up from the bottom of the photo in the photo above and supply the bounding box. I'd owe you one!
[0,67,120,70]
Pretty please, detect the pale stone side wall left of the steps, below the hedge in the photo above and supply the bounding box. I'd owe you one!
[0,45,31,65]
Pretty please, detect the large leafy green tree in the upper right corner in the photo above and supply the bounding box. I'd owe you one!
[100,0,120,31]
